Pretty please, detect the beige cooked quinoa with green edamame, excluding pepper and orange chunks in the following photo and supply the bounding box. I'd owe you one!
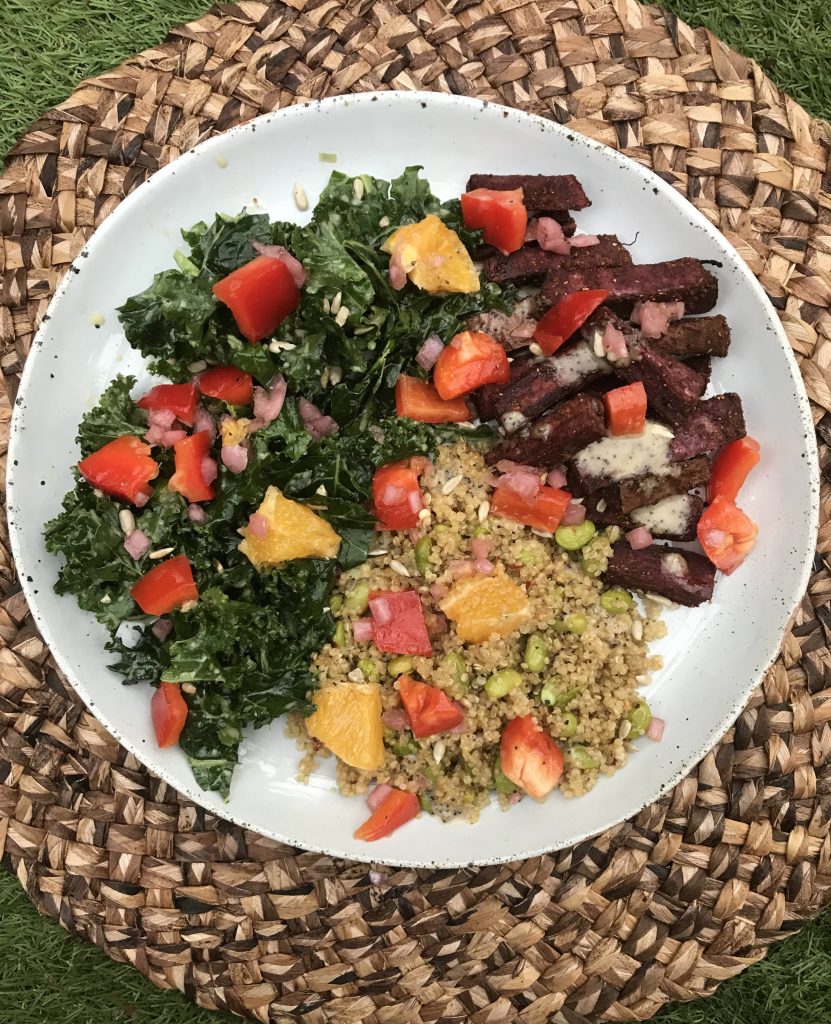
[289,441,666,821]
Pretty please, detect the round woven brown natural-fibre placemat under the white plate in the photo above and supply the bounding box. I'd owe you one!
[0,0,831,1024]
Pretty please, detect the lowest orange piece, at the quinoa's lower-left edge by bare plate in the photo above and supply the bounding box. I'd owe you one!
[306,683,384,771]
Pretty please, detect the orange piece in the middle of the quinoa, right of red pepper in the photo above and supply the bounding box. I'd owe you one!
[439,575,531,643]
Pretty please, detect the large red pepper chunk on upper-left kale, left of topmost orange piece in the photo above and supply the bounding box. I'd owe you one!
[213,256,300,345]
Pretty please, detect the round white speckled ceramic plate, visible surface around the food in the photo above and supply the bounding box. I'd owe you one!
[8,92,818,867]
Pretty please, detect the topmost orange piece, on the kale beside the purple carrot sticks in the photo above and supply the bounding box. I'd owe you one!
[381,213,479,295]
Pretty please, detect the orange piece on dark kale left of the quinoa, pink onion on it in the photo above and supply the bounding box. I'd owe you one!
[239,487,341,568]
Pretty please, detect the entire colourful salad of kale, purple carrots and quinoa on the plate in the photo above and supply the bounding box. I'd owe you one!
[45,167,760,842]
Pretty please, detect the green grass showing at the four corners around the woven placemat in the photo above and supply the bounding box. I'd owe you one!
[0,0,831,1024]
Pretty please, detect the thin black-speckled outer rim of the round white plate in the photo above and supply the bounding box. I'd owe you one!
[7,91,820,868]
